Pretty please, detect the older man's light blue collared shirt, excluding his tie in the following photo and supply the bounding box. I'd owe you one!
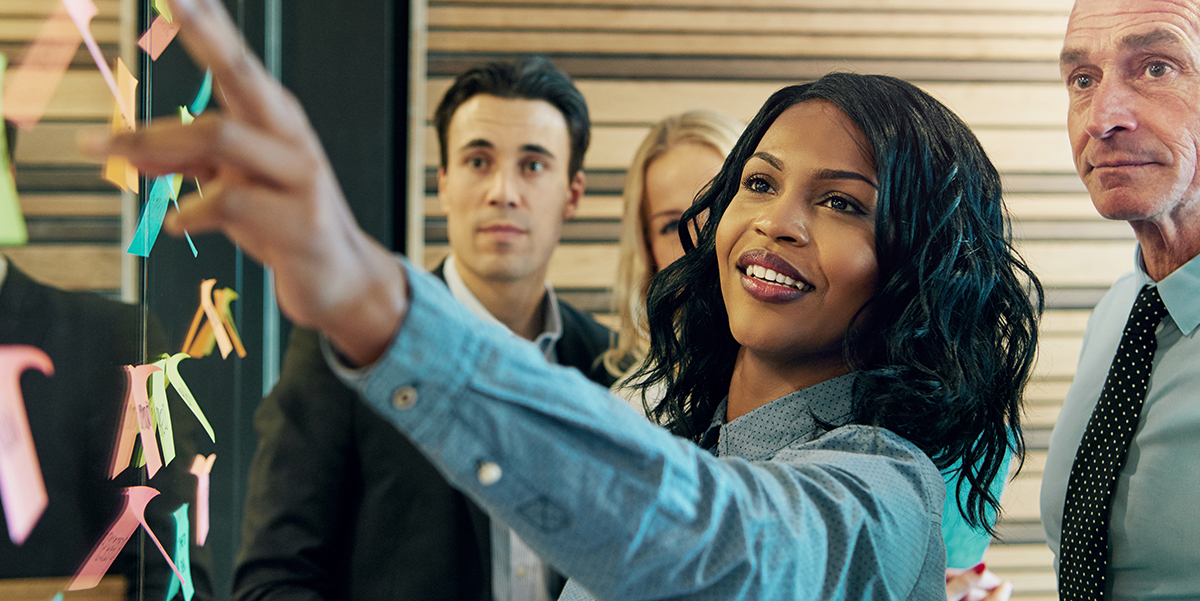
[1042,245,1200,600]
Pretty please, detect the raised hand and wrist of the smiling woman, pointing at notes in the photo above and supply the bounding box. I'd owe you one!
[83,0,406,365]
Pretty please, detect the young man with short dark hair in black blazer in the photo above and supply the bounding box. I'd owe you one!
[234,58,611,601]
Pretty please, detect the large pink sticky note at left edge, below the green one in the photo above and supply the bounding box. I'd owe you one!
[0,344,54,545]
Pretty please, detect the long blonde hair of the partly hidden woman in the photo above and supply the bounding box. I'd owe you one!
[602,110,743,377]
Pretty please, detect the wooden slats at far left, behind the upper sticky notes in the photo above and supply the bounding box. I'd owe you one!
[0,0,125,298]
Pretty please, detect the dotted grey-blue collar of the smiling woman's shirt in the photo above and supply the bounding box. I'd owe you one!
[709,373,857,461]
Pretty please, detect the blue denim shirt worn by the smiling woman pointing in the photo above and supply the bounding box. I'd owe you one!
[329,265,946,600]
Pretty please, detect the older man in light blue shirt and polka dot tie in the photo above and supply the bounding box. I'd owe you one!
[1042,0,1200,600]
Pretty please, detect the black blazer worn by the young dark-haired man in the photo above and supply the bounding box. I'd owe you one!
[233,266,613,601]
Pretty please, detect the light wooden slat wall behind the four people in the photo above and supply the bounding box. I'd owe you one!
[425,0,1113,600]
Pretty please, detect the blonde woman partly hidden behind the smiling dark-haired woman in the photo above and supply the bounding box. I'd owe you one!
[602,110,743,388]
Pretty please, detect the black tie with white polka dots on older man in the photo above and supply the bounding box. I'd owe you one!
[1058,286,1166,601]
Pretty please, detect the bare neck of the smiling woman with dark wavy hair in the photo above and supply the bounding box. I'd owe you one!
[725,347,850,421]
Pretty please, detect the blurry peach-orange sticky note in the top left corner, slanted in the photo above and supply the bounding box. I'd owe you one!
[4,4,83,130]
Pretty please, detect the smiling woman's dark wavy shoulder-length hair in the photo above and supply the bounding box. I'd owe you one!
[634,73,1042,531]
